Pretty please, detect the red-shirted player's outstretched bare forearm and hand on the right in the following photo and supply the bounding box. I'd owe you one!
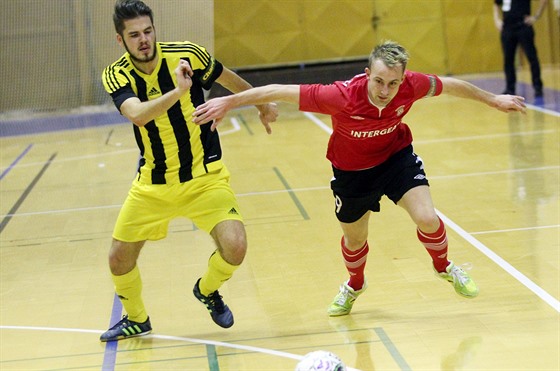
[440,77,525,112]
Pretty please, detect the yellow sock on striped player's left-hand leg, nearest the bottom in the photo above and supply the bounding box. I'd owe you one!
[112,266,148,323]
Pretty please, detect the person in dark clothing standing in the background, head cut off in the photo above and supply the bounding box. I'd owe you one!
[494,0,548,98]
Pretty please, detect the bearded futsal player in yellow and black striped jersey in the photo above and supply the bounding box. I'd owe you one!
[100,0,278,341]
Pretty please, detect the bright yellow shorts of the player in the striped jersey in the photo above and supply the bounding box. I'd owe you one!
[113,166,243,242]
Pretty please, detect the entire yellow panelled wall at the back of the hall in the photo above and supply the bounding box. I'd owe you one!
[214,0,560,74]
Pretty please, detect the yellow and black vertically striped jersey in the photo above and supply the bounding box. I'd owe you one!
[102,41,223,184]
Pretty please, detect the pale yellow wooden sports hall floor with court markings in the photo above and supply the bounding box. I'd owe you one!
[0,67,560,371]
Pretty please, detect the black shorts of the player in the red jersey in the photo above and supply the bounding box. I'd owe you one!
[331,145,429,223]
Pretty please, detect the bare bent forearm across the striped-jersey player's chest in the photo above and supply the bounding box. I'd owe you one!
[120,88,183,127]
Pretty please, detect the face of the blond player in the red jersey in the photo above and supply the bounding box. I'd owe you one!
[365,59,404,107]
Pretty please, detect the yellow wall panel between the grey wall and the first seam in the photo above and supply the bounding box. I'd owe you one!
[215,0,375,67]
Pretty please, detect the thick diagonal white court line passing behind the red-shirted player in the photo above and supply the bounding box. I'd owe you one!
[303,111,560,312]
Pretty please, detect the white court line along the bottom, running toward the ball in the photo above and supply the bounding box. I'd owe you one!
[0,326,360,371]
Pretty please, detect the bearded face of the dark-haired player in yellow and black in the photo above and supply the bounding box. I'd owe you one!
[117,16,156,63]
